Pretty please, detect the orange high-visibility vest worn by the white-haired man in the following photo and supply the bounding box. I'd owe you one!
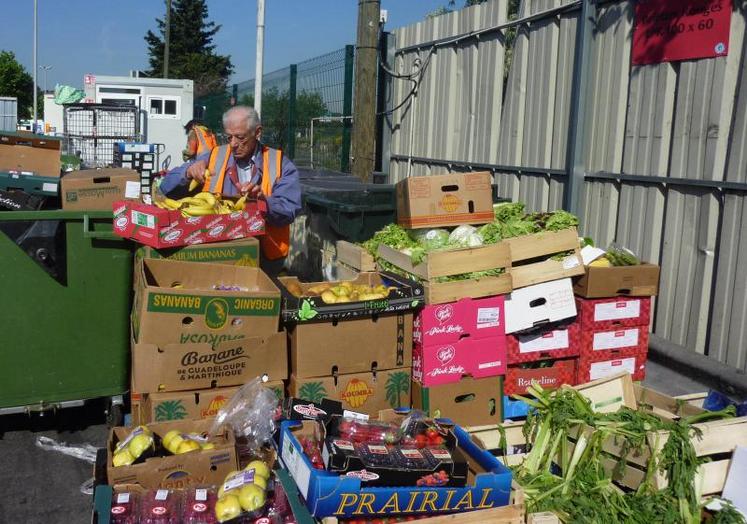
[202,145,290,260]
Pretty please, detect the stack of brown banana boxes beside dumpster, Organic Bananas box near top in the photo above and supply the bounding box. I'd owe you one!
[131,238,288,423]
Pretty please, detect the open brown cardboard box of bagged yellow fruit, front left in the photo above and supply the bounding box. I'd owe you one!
[107,420,238,489]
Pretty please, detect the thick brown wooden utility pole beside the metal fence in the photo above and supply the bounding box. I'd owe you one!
[345,0,381,182]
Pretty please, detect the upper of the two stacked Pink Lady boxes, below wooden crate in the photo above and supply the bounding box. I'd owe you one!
[412,295,506,347]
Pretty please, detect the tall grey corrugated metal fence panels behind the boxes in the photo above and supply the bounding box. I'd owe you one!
[391,0,747,370]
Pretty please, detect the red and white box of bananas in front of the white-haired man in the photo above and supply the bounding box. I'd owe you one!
[113,200,267,249]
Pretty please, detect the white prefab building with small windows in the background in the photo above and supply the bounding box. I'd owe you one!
[83,75,194,167]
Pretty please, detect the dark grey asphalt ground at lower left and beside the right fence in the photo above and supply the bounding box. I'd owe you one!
[0,362,708,524]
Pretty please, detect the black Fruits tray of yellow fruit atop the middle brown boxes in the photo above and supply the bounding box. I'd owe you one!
[279,271,424,324]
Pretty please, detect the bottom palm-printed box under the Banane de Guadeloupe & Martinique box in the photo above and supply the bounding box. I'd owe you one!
[141,380,285,424]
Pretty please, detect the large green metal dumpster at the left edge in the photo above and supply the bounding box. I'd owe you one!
[0,211,133,412]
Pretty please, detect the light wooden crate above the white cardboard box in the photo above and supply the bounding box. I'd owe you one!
[501,228,584,289]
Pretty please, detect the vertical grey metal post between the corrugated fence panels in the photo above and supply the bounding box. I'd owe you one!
[563,0,597,219]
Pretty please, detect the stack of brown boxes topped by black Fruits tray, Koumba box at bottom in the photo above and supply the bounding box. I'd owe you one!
[280,272,422,415]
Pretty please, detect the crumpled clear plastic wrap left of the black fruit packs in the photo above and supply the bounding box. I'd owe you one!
[210,377,278,451]
